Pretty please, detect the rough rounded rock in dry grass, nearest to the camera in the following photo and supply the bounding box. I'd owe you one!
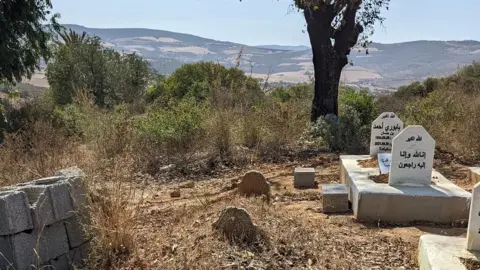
[212,206,258,243]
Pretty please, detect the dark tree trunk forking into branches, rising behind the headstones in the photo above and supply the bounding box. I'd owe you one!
[295,0,390,121]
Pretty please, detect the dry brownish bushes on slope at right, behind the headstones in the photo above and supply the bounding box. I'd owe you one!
[376,62,480,161]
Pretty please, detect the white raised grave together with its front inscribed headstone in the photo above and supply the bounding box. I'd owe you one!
[340,119,471,223]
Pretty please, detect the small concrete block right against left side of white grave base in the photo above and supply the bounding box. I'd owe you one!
[322,184,349,213]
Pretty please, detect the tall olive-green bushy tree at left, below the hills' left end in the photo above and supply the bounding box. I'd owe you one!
[46,32,152,107]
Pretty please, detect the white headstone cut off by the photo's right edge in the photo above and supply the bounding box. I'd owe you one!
[467,183,480,251]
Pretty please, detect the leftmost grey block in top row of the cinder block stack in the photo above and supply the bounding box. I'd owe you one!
[0,190,33,235]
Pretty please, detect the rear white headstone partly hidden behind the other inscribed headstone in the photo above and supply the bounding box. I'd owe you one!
[370,112,403,157]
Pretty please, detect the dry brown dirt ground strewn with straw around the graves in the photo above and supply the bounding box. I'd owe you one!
[123,154,472,269]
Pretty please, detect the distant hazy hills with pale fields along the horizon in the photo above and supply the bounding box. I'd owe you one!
[38,25,480,90]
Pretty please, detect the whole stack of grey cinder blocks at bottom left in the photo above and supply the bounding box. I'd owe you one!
[0,167,88,270]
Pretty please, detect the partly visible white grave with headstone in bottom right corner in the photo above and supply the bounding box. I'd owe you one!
[418,175,480,270]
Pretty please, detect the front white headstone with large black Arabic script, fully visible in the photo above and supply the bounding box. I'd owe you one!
[388,126,435,185]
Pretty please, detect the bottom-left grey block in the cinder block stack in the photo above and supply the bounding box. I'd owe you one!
[0,232,37,270]
